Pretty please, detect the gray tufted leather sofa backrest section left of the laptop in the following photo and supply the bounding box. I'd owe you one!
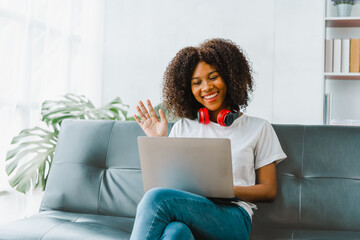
[40,120,172,217]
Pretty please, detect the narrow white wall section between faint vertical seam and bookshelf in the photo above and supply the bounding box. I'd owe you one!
[272,0,325,124]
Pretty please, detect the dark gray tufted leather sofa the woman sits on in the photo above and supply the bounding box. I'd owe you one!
[0,120,360,240]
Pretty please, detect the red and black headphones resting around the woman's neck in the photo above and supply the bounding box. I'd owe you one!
[197,108,240,127]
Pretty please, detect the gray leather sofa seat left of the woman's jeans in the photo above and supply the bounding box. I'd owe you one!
[0,211,134,240]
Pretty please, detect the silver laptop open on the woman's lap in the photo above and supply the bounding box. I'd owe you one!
[138,137,235,198]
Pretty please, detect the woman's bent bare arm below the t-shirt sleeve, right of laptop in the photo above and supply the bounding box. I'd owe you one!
[234,163,277,202]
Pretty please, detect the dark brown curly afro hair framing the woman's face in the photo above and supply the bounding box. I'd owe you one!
[163,38,254,119]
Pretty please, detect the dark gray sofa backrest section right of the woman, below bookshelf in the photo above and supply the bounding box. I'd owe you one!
[253,125,360,231]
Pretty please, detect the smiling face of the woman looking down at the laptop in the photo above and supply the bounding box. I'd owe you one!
[191,62,227,119]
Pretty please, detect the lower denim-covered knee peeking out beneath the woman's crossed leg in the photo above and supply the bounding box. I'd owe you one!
[161,222,195,240]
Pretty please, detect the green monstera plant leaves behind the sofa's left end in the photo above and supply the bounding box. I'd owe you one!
[5,94,128,193]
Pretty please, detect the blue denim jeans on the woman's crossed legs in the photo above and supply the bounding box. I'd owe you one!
[130,188,251,240]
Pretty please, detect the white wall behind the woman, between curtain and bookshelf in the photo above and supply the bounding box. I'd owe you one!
[102,0,325,124]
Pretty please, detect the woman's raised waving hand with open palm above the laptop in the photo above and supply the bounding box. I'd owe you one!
[134,100,168,137]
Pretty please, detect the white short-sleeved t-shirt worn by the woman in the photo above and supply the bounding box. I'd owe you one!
[169,114,286,217]
